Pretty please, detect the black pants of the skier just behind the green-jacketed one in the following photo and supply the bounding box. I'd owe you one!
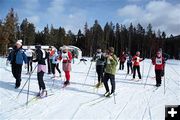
[96,65,104,82]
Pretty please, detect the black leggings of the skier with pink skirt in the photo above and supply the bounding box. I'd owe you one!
[37,71,46,90]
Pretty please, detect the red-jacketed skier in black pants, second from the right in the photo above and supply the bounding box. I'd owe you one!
[132,51,144,79]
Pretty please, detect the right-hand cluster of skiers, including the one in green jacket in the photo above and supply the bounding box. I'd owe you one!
[92,47,168,97]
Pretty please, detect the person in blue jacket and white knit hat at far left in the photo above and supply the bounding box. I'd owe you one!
[7,40,27,89]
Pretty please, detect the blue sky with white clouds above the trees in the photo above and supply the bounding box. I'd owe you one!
[0,0,180,35]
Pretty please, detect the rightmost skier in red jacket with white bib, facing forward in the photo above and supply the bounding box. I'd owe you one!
[152,51,165,87]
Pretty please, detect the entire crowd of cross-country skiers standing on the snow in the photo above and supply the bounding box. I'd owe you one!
[8,40,167,97]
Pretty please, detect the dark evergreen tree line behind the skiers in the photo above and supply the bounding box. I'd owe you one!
[0,8,180,59]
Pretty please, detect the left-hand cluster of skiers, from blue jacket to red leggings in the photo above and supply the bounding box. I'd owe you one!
[7,40,72,97]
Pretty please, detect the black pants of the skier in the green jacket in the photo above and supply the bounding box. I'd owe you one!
[104,73,115,93]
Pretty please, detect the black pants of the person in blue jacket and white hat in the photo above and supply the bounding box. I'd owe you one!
[11,63,22,87]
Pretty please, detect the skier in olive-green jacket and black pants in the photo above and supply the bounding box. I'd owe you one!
[104,47,118,97]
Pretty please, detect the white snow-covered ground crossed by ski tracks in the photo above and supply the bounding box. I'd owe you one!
[0,58,180,120]
